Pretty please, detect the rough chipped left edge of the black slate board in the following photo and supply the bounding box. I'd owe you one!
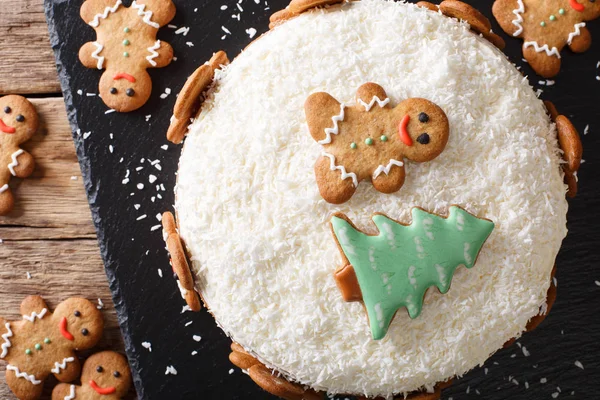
[44,0,145,399]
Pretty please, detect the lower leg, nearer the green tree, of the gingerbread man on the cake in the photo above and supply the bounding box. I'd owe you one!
[315,156,356,204]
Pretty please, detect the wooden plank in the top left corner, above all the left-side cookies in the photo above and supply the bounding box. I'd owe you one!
[0,0,60,94]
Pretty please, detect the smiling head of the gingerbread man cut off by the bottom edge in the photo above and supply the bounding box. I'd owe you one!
[81,351,131,398]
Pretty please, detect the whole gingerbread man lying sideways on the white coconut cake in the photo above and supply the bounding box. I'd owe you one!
[304,83,449,204]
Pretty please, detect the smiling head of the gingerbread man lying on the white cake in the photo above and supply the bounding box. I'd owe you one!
[393,98,450,162]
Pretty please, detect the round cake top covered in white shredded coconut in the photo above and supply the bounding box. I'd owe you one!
[176,0,567,396]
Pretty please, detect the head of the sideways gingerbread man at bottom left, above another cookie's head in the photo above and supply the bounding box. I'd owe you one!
[54,298,104,350]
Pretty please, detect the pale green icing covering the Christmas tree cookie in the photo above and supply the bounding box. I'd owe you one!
[331,206,494,340]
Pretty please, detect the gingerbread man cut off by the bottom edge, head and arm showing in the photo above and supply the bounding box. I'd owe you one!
[52,351,131,400]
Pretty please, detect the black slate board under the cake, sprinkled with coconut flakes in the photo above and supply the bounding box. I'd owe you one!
[45,0,600,400]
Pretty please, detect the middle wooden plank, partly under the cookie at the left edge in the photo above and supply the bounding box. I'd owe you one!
[0,98,96,241]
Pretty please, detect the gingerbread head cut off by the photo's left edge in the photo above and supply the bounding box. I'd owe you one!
[0,95,39,145]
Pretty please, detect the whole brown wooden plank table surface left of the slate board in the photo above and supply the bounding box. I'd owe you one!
[0,0,123,399]
